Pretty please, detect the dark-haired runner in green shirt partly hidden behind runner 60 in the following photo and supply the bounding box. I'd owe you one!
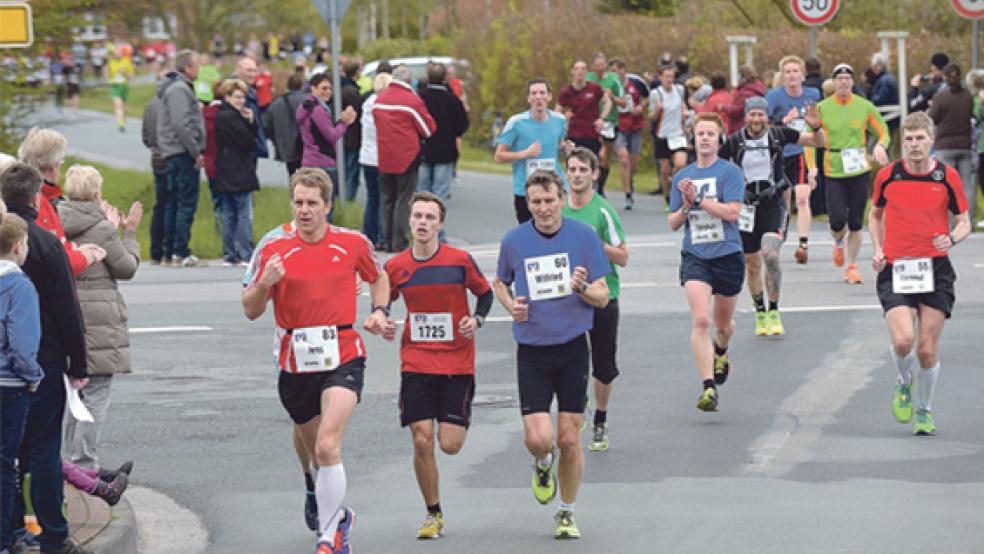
[561,146,629,452]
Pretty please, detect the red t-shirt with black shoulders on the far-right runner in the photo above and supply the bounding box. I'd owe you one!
[872,161,967,263]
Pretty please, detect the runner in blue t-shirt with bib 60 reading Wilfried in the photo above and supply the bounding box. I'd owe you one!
[493,170,611,538]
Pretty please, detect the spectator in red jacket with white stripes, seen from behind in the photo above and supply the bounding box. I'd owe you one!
[372,65,437,252]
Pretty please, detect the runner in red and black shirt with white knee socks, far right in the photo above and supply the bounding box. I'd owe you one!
[868,112,970,435]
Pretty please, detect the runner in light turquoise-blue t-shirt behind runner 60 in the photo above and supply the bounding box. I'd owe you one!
[495,77,574,223]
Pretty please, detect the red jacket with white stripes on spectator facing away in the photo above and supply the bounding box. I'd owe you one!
[372,81,437,175]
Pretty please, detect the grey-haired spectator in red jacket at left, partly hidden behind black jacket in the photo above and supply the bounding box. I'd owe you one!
[17,127,106,275]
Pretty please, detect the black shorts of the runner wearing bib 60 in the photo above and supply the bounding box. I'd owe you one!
[516,335,588,415]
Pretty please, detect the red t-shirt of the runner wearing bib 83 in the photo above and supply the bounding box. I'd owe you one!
[248,226,382,373]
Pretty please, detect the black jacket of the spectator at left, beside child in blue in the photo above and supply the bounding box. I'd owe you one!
[7,204,89,380]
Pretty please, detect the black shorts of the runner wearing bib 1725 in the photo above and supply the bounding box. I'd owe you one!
[400,371,475,428]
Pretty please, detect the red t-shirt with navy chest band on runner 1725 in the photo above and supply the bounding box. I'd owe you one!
[386,244,490,375]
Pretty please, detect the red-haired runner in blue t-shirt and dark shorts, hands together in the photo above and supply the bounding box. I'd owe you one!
[669,112,745,412]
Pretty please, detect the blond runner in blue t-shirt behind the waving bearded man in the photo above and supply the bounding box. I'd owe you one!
[765,56,821,264]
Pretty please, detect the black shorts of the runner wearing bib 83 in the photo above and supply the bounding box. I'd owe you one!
[277,358,366,425]
